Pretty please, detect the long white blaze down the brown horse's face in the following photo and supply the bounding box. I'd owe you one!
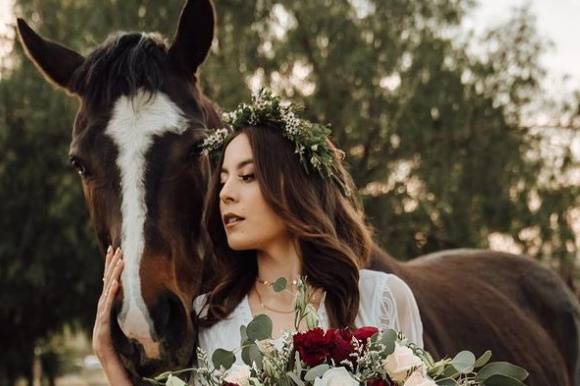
[105,90,188,358]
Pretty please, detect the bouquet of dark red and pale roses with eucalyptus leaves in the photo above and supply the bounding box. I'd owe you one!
[145,278,528,386]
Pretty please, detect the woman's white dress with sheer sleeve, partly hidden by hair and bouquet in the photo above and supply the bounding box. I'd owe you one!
[193,269,423,364]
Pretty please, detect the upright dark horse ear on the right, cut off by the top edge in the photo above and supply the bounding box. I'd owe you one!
[169,0,215,76]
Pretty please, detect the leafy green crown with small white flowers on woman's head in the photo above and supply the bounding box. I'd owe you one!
[200,88,350,196]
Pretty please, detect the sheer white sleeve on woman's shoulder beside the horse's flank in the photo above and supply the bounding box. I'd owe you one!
[381,275,423,347]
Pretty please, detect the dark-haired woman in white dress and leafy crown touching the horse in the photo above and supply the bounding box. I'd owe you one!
[93,91,423,385]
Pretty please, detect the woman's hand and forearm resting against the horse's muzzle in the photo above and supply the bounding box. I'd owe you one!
[93,247,123,362]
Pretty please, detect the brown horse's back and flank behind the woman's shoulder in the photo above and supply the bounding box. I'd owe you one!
[371,249,580,386]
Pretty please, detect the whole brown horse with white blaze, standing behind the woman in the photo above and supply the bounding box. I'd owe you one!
[18,0,580,386]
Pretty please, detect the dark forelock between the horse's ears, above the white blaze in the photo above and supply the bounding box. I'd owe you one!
[70,32,168,105]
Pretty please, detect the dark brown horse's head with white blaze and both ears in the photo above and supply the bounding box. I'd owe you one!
[18,0,217,376]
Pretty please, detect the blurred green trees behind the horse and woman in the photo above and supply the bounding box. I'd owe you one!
[0,0,580,385]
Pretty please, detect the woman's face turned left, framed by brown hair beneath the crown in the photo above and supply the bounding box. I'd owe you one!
[219,133,287,250]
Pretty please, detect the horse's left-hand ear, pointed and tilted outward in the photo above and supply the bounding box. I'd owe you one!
[18,18,85,92]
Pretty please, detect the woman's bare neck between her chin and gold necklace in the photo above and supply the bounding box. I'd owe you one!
[257,238,302,282]
